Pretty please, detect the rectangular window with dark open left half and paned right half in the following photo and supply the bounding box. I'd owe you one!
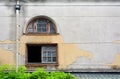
[27,44,57,64]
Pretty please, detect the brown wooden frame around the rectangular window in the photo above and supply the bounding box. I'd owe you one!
[25,43,59,67]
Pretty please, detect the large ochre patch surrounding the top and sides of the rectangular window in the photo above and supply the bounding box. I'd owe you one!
[20,35,93,69]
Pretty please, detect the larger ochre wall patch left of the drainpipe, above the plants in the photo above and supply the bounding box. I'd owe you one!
[0,48,15,65]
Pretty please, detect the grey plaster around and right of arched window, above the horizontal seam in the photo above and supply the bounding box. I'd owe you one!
[25,5,120,43]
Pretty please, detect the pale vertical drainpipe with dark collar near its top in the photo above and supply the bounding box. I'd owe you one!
[15,0,21,71]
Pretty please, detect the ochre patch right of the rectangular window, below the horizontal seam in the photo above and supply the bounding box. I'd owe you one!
[59,44,93,69]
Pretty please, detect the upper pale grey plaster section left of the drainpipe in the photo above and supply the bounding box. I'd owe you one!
[0,5,15,40]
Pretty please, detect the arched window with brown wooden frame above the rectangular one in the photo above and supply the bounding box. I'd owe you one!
[26,17,57,34]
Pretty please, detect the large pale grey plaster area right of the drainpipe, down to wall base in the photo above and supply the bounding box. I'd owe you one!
[21,3,120,69]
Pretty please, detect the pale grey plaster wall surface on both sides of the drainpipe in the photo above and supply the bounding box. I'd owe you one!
[0,0,120,69]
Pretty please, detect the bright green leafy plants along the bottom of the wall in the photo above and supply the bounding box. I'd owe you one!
[0,65,76,79]
